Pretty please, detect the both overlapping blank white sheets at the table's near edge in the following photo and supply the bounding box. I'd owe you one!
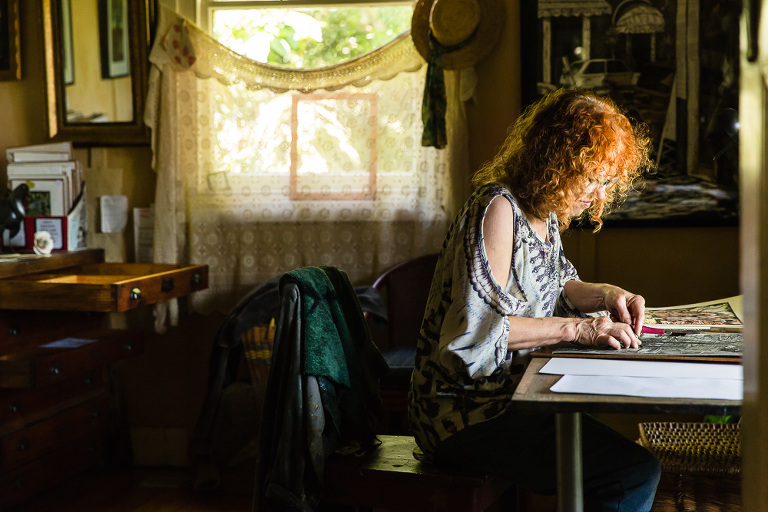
[540,357,744,400]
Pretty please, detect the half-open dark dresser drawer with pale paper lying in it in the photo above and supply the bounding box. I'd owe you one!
[0,329,143,389]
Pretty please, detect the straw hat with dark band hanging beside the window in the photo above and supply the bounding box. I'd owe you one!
[411,0,505,69]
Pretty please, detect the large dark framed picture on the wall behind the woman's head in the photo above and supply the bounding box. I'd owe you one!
[520,0,741,223]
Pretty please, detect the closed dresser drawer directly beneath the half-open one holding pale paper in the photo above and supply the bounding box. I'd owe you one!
[0,368,106,436]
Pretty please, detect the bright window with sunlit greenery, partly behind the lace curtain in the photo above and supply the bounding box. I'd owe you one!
[192,1,423,206]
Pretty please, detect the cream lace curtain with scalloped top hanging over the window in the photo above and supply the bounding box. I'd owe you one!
[145,6,467,314]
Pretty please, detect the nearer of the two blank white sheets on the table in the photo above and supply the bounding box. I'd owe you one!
[550,375,744,400]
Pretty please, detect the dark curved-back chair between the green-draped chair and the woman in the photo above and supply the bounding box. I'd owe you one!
[368,254,438,434]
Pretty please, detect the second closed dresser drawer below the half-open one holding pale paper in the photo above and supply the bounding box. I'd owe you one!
[0,395,109,473]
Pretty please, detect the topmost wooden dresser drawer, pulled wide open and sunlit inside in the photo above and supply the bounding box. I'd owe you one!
[0,263,208,312]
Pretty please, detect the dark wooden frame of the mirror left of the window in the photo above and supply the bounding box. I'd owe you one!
[43,0,155,146]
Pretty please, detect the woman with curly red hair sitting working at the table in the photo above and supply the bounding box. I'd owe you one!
[409,89,660,511]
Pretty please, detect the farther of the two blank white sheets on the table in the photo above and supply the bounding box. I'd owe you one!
[539,357,744,380]
